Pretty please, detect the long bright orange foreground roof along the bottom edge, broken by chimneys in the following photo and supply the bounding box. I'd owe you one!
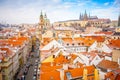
[40,63,95,80]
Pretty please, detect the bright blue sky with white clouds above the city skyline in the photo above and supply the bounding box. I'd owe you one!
[0,0,120,24]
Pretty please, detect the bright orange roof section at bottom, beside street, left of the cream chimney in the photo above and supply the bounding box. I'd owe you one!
[40,63,62,80]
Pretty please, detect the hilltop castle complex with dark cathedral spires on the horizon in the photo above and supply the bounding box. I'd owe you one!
[54,10,113,28]
